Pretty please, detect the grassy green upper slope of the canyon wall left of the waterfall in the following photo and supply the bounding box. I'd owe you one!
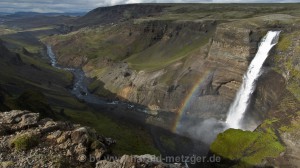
[43,17,214,72]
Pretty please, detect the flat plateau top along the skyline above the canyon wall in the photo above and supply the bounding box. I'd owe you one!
[72,3,300,28]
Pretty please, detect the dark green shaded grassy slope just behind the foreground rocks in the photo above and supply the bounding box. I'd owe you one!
[59,109,159,155]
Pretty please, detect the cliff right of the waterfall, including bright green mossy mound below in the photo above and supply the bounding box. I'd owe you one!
[211,16,300,167]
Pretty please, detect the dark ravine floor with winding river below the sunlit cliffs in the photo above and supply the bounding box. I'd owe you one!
[47,45,209,165]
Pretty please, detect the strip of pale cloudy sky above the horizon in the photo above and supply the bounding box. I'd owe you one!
[0,0,300,13]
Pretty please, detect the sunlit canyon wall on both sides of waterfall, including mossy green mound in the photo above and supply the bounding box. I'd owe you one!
[48,11,299,166]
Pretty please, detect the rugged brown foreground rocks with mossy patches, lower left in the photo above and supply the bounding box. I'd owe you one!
[0,110,180,168]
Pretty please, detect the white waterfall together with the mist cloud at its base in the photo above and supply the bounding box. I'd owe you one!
[177,31,280,145]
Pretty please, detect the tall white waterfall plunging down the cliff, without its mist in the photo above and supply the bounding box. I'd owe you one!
[226,31,280,129]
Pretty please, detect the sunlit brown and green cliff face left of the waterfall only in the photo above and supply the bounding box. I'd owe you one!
[48,18,273,124]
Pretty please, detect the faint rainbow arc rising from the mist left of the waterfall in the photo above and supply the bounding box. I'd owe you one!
[171,71,211,133]
